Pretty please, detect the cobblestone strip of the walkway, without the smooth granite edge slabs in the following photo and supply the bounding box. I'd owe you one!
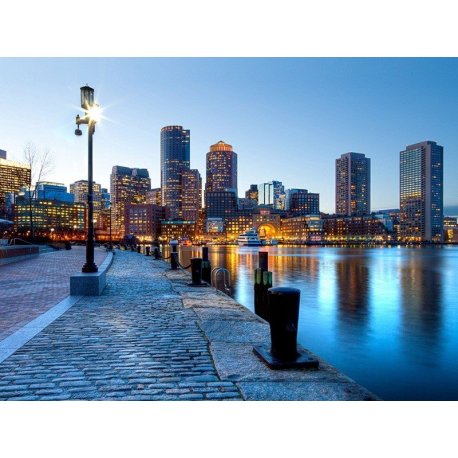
[0,251,242,400]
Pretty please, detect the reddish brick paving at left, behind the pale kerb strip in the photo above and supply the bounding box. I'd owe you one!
[0,246,106,340]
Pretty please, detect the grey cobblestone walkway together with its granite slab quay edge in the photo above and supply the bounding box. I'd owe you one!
[0,251,375,400]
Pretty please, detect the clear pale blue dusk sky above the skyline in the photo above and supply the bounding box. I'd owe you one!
[0,58,458,214]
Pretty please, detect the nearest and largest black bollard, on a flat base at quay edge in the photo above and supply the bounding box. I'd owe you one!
[253,288,319,369]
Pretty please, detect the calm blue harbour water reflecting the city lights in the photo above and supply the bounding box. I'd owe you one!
[176,246,458,400]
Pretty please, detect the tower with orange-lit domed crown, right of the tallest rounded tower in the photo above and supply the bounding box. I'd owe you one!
[205,140,238,197]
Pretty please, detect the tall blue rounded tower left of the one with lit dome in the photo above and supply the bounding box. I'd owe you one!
[161,126,190,219]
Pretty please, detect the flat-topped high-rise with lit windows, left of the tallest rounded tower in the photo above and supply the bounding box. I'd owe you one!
[110,165,151,239]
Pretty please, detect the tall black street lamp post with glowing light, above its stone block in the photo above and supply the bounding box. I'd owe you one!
[75,86,100,273]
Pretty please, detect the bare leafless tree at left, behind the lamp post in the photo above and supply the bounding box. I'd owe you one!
[24,142,54,241]
